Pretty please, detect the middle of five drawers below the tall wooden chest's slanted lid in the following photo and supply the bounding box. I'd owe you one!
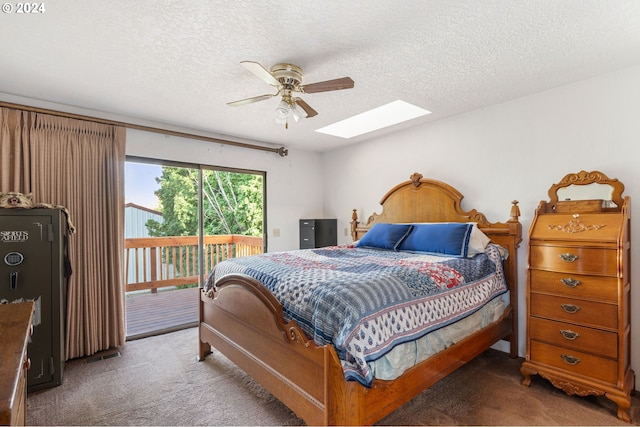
[529,293,618,329]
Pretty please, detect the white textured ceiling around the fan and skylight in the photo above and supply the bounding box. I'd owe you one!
[0,0,640,151]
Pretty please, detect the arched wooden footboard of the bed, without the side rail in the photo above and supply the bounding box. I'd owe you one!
[199,275,346,425]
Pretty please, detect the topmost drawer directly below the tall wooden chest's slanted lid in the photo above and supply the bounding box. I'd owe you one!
[529,245,618,277]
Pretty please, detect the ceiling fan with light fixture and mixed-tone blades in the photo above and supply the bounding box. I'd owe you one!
[227,61,354,128]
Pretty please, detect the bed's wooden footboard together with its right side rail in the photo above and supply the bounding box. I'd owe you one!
[199,275,513,425]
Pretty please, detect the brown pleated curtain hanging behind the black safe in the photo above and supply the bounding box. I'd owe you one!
[0,108,126,359]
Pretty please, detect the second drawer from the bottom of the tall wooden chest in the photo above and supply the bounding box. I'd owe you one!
[529,317,618,359]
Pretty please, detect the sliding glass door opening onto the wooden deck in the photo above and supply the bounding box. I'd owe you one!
[125,158,265,339]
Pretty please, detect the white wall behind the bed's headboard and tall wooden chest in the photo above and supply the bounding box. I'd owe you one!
[322,66,640,372]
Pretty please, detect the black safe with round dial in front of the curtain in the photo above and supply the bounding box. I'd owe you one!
[0,208,70,391]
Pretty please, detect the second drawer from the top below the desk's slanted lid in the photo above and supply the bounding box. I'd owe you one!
[529,270,618,304]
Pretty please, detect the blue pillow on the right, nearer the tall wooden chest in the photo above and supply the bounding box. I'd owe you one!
[397,223,473,258]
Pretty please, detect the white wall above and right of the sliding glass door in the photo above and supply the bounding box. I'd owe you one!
[126,129,324,252]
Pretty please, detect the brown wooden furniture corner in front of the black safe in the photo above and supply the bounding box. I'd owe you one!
[0,302,33,425]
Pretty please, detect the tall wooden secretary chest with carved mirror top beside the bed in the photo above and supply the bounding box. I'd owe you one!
[521,171,635,422]
